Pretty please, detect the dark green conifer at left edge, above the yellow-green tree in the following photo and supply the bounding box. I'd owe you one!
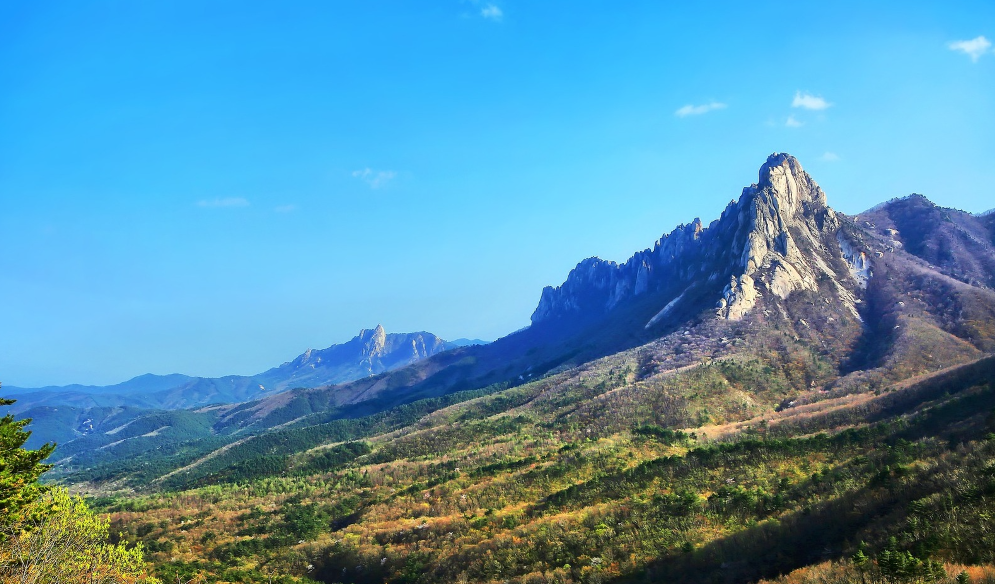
[0,388,55,524]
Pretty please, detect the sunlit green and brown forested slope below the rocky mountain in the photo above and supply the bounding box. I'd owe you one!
[89,341,995,582]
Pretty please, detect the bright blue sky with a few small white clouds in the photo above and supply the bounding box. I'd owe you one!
[0,0,995,386]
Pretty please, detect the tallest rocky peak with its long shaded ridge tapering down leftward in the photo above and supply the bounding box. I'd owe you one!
[202,154,871,426]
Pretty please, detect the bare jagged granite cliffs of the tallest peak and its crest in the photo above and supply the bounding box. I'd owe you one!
[532,154,872,326]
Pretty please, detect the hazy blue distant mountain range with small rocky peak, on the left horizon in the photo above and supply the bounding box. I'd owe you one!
[3,325,486,413]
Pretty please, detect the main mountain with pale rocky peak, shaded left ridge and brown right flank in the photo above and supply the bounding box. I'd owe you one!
[193,154,995,434]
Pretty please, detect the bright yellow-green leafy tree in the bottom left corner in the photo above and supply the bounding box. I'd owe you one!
[0,488,159,584]
